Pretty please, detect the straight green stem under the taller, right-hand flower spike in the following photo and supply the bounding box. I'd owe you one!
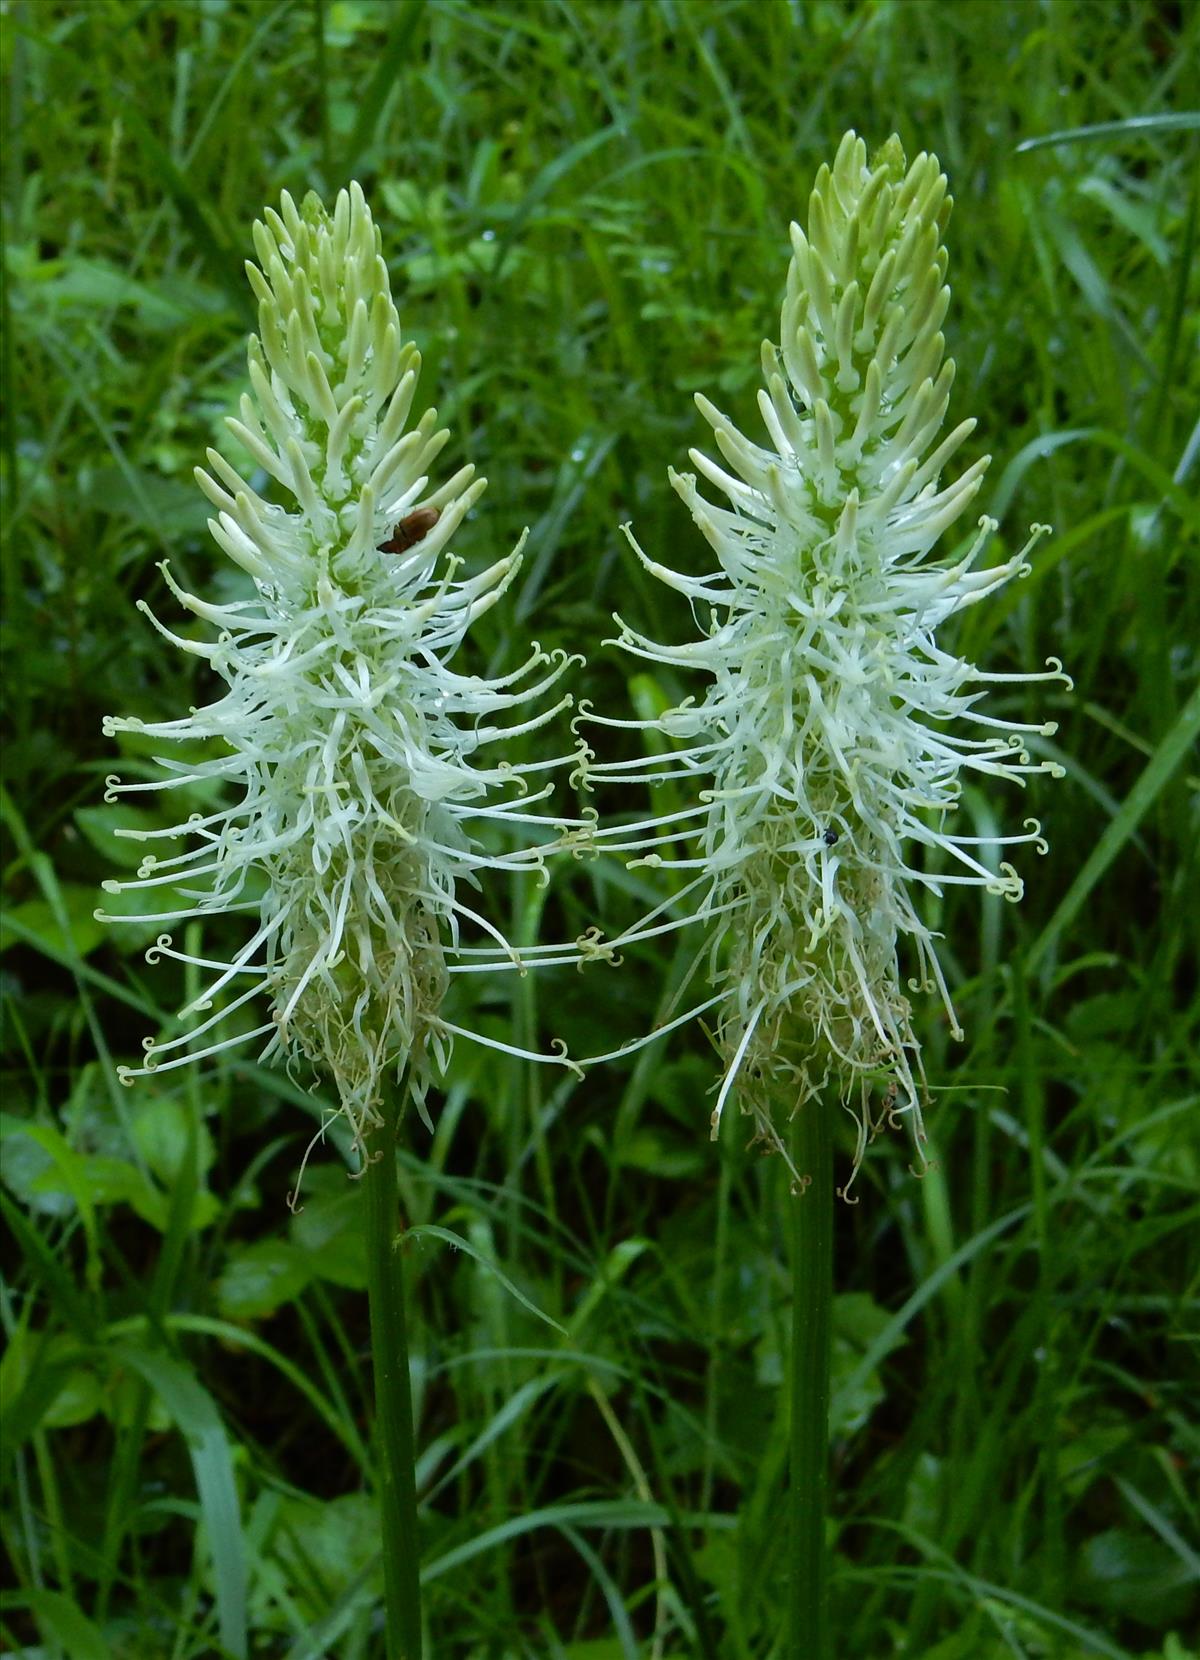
[787,1101,833,1660]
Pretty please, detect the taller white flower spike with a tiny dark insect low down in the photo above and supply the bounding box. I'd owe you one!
[588,133,1069,1174]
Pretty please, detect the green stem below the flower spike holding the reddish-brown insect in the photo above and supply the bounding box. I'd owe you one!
[362,1116,422,1660]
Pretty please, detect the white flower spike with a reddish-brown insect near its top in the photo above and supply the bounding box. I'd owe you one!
[100,175,594,1149]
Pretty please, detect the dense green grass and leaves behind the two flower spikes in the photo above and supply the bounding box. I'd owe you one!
[0,0,1200,1660]
